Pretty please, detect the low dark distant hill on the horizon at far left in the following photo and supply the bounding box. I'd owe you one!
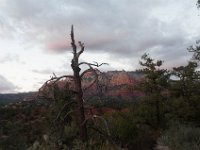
[0,92,37,105]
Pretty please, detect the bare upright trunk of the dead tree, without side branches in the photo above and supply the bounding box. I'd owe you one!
[71,26,87,141]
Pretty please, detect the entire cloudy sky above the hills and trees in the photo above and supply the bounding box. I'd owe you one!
[0,0,200,93]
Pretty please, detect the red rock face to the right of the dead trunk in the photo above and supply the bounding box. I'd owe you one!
[83,71,143,99]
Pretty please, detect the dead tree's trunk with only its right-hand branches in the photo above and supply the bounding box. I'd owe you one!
[71,25,107,141]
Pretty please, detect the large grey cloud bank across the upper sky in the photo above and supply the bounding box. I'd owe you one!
[0,0,195,67]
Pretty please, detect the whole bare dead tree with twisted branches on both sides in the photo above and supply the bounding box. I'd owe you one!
[38,25,107,141]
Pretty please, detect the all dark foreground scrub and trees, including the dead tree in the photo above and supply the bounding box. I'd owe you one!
[0,26,200,150]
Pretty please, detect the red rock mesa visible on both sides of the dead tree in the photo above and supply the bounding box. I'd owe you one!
[41,70,143,100]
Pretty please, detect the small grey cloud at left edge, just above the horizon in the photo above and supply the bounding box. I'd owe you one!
[0,75,18,93]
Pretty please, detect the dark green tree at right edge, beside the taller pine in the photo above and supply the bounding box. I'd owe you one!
[167,62,200,124]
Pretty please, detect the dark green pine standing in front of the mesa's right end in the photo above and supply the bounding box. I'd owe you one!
[136,54,170,127]
